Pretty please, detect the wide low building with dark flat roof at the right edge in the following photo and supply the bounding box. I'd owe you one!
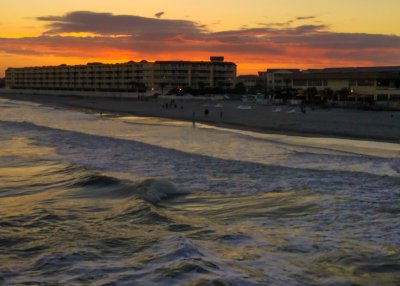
[284,66,400,101]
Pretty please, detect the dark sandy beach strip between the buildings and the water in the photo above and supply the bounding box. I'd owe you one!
[0,93,400,143]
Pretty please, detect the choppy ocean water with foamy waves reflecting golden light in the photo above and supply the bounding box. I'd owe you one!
[0,99,400,286]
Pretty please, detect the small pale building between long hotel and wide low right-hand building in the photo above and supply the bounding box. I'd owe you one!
[258,69,300,92]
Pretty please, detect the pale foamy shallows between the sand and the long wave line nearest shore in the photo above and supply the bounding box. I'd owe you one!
[0,100,400,179]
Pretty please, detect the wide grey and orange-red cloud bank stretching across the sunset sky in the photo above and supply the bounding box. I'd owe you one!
[0,11,400,67]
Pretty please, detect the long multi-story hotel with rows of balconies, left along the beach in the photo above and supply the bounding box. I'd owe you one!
[5,57,236,91]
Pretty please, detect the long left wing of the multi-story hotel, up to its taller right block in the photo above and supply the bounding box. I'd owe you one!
[6,61,153,91]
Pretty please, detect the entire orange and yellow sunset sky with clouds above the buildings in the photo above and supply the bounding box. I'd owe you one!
[0,0,400,77]
